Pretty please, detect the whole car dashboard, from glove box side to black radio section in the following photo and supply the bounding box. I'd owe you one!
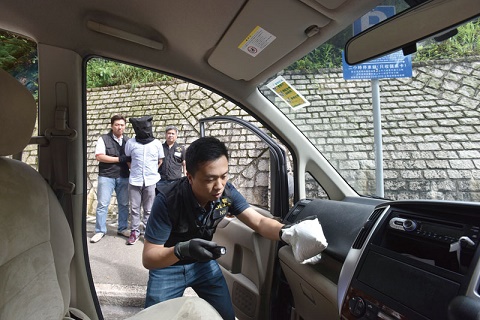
[279,198,480,320]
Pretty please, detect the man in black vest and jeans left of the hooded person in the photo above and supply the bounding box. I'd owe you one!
[90,115,131,243]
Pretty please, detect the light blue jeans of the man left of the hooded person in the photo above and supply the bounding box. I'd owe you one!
[95,176,128,233]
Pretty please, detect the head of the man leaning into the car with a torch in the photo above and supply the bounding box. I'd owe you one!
[185,137,228,206]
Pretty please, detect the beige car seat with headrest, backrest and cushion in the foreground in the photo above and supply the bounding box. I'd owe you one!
[0,69,221,320]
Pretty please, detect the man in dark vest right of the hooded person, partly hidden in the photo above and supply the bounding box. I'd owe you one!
[157,126,187,193]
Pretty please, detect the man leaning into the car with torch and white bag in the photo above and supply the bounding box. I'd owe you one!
[142,137,327,320]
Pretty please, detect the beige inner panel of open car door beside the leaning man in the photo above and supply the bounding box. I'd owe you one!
[213,208,277,319]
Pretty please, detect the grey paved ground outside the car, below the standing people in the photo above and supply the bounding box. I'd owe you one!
[87,217,195,320]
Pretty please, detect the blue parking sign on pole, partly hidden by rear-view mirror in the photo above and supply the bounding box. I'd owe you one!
[342,6,412,80]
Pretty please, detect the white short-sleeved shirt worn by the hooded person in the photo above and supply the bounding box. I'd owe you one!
[125,138,164,187]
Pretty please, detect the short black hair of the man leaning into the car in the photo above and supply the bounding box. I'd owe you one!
[185,137,228,176]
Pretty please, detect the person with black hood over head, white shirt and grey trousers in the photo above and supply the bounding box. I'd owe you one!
[125,116,164,245]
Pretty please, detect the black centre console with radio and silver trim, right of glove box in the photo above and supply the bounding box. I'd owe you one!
[338,201,480,320]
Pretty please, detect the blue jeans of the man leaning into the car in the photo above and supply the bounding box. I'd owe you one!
[145,260,235,320]
